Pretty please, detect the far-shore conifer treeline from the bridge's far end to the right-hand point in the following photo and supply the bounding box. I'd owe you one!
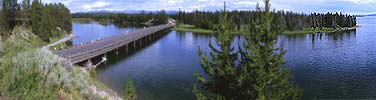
[170,8,356,31]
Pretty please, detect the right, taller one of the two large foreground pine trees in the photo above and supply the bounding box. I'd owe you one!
[242,0,301,100]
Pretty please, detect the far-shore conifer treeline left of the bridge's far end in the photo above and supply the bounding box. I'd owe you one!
[72,10,168,25]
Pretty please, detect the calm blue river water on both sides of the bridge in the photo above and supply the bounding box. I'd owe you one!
[74,17,376,100]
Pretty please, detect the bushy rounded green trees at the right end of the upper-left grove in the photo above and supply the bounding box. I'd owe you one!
[31,0,72,41]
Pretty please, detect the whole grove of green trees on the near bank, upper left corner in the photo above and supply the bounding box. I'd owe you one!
[0,0,72,41]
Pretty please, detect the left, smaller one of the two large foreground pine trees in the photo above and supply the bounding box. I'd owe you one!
[193,1,241,100]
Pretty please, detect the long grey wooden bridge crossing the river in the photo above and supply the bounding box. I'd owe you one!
[54,24,175,64]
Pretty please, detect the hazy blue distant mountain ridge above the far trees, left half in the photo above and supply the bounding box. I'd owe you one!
[76,10,179,14]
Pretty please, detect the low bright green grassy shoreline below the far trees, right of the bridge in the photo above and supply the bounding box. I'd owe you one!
[172,24,356,35]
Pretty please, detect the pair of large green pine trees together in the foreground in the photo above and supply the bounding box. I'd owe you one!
[193,0,301,100]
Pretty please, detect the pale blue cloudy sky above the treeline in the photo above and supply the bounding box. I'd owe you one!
[37,0,376,14]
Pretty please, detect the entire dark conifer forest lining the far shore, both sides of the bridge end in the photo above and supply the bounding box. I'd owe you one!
[72,8,357,31]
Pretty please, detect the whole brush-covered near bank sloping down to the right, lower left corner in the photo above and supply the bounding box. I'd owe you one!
[0,27,119,100]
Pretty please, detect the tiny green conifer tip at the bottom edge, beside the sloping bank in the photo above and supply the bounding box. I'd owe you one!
[124,76,137,100]
